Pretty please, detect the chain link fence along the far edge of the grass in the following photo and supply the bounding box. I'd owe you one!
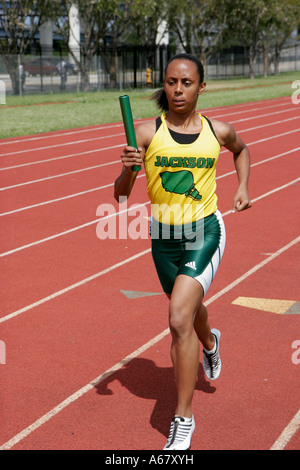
[0,43,300,95]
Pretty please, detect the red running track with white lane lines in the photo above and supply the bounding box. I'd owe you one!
[0,93,300,450]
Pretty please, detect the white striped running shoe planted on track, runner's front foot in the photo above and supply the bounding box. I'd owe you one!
[163,416,195,450]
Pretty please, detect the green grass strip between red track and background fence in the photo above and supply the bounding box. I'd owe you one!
[0,72,300,139]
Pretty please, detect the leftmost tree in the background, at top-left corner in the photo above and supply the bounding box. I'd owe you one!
[0,0,52,94]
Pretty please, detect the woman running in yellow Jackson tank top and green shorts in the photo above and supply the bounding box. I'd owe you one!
[115,54,251,450]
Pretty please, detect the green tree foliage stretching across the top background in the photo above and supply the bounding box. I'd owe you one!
[0,0,300,89]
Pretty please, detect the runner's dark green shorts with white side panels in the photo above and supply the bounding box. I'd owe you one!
[151,211,226,295]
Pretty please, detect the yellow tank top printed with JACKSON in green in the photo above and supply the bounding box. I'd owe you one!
[145,114,220,225]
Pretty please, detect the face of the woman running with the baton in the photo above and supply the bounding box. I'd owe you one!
[165,59,205,113]
